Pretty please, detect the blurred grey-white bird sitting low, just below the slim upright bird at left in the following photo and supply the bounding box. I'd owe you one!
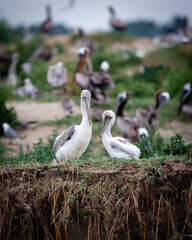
[12,78,40,99]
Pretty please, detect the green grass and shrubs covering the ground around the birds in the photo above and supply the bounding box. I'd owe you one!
[0,31,192,166]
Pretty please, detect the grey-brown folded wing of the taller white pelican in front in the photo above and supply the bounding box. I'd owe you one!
[53,126,75,154]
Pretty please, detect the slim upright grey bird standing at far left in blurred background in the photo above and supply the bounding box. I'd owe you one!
[7,52,19,86]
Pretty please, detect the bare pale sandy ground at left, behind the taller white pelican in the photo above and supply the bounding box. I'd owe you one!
[0,101,81,156]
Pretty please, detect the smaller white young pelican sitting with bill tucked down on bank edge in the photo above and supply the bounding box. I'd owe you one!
[100,110,140,159]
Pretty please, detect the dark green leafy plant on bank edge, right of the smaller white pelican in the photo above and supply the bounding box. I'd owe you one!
[163,133,191,156]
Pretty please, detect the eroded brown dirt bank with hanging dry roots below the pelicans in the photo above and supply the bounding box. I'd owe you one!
[0,162,192,240]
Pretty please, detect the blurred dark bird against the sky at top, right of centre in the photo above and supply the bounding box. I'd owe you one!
[108,6,127,31]
